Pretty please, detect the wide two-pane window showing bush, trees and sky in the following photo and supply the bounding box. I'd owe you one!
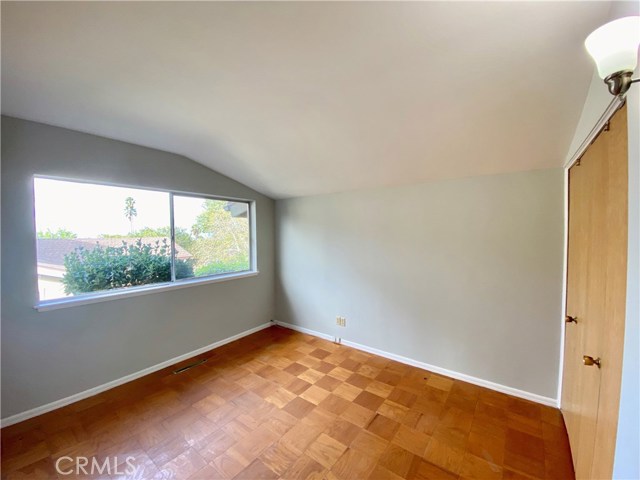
[34,177,253,304]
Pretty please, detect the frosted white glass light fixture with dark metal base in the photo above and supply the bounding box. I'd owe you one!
[584,16,640,95]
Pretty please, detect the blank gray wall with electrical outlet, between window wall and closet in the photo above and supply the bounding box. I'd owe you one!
[276,169,563,399]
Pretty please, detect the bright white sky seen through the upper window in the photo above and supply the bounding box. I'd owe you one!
[33,177,203,238]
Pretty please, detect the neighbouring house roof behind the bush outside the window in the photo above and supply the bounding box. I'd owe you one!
[38,237,192,267]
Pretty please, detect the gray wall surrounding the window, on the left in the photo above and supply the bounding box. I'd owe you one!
[1,117,274,418]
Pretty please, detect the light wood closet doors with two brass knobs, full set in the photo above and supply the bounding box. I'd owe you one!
[562,103,628,479]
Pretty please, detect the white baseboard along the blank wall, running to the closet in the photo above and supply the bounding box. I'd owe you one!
[274,320,558,408]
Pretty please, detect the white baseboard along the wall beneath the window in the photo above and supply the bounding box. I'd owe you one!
[0,322,273,428]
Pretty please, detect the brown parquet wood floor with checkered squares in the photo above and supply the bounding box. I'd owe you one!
[2,327,573,480]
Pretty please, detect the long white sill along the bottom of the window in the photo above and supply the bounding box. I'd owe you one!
[33,270,259,312]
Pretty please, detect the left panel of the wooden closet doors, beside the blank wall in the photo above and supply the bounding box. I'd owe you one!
[563,125,605,478]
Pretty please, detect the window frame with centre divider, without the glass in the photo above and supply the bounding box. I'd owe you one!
[31,174,260,312]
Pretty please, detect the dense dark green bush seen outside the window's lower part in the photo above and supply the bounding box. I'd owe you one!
[62,239,193,295]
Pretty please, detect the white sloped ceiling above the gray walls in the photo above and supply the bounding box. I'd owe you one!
[2,2,610,198]
